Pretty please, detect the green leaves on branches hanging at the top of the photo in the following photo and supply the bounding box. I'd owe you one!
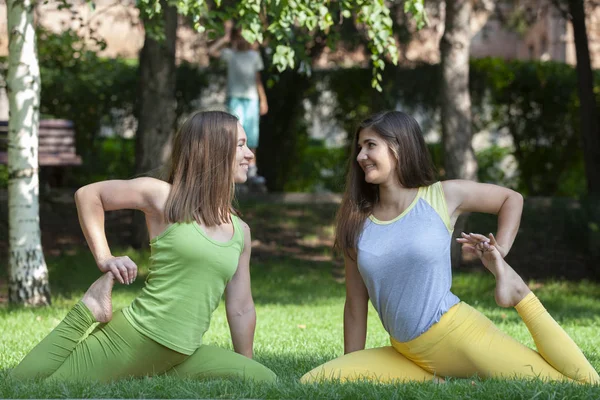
[136,0,427,91]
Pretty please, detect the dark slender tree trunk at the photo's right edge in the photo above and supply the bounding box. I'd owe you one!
[568,0,600,198]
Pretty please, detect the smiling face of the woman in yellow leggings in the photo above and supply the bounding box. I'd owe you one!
[356,128,398,185]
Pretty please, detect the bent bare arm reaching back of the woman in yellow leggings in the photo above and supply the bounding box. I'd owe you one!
[442,180,523,257]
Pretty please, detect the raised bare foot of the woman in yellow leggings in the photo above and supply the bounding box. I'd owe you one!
[477,243,531,307]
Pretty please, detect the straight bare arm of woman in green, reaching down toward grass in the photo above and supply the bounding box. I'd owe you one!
[225,222,256,358]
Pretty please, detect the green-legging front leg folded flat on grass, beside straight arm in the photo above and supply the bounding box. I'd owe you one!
[166,345,277,383]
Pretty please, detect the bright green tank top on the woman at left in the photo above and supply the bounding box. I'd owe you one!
[123,216,244,355]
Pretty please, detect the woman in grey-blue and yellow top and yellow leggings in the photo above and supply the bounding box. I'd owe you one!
[302,111,600,383]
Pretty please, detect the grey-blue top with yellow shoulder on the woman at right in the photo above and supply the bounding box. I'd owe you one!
[357,182,460,342]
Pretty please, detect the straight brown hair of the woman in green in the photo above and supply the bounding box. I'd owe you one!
[165,111,238,226]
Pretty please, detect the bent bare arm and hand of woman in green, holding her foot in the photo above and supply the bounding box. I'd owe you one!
[75,178,170,283]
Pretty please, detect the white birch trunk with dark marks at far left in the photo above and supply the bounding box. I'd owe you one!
[6,0,50,306]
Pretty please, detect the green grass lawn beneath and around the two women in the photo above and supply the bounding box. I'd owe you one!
[0,203,600,400]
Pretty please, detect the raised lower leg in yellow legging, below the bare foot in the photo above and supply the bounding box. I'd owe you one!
[515,293,600,383]
